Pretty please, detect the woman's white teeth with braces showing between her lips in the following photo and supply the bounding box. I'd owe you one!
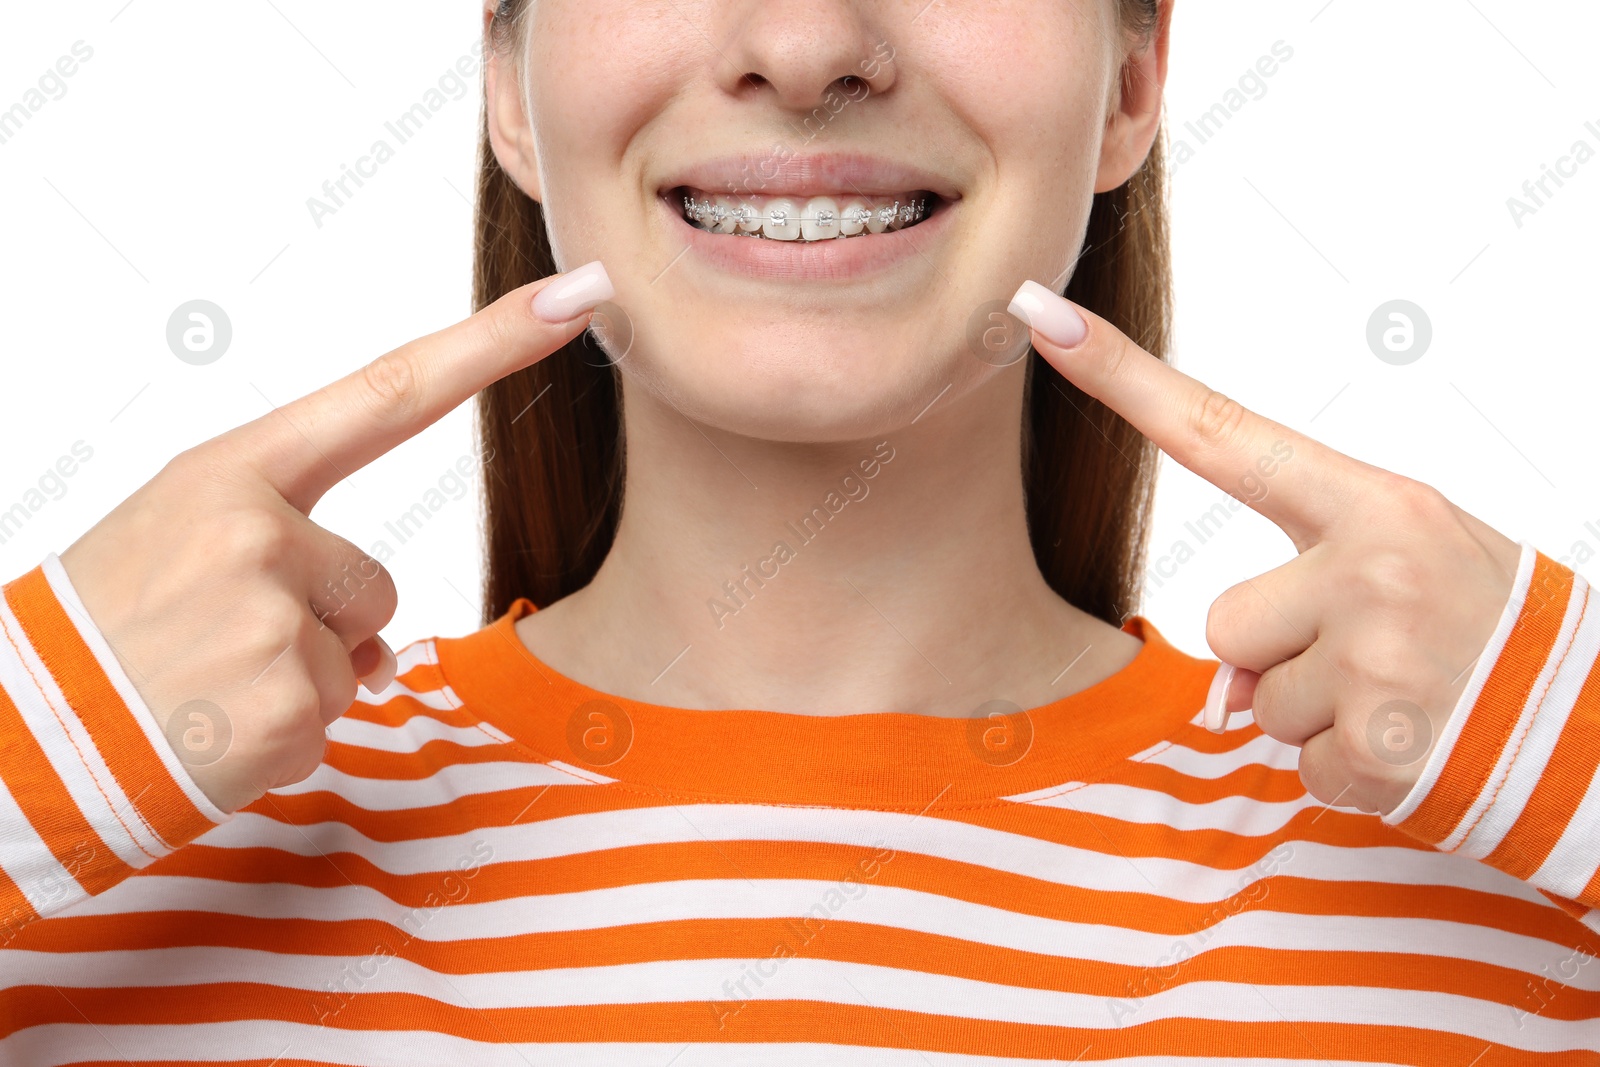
[667,186,941,243]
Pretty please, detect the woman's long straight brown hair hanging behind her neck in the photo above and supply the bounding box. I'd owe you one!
[472,0,1173,625]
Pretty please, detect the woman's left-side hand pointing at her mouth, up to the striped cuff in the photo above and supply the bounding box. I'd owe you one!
[61,262,611,811]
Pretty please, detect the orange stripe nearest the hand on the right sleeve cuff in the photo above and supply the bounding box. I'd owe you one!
[1400,552,1573,845]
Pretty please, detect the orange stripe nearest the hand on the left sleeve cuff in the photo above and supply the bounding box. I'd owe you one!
[5,566,213,859]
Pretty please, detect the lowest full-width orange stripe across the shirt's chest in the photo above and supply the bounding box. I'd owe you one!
[11,984,1600,1067]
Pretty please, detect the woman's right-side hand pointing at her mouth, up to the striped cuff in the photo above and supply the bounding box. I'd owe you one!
[1011,282,1522,813]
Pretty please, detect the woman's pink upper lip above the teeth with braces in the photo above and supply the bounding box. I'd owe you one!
[661,152,962,200]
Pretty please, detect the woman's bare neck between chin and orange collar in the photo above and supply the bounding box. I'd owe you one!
[518,364,1139,715]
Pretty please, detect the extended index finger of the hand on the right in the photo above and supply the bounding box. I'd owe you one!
[1011,282,1374,550]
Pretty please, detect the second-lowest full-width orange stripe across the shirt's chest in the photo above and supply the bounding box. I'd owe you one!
[12,912,1600,1021]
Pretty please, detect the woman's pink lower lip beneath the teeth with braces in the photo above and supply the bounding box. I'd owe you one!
[659,197,960,282]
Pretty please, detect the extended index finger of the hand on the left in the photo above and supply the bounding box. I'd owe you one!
[222,259,614,514]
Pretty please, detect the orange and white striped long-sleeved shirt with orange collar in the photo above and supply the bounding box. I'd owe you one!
[0,544,1600,1067]
